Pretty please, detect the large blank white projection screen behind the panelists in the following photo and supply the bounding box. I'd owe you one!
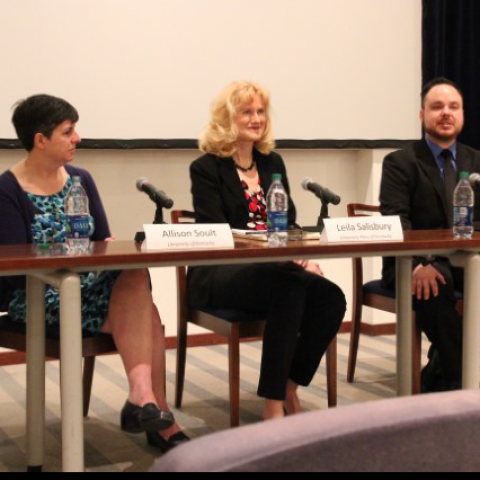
[0,0,421,139]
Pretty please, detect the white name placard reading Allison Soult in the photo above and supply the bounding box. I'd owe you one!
[143,224,235,250]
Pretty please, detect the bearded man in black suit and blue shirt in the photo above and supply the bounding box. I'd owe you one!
[380,78,480,392]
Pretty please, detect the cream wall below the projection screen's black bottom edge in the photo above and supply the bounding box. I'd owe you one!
[0,150,391,336]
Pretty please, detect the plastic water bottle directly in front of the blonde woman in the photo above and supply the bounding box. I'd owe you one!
[267,174,288,247]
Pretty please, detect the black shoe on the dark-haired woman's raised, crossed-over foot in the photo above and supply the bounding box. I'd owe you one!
[120,401,175,433]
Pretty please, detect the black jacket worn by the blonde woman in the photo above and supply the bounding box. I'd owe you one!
[188,151,296,308]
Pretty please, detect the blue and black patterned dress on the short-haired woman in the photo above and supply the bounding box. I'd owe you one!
[8,177,121,335]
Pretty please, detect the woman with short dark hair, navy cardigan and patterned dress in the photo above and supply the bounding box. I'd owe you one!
[0,95,188,452]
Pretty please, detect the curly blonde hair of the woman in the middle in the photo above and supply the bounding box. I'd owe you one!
[199,82,275,158]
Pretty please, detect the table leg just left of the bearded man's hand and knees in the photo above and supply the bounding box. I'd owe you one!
[397,257,413,396]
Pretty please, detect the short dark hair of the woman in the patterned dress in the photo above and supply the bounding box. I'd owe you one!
[12,95,80,152]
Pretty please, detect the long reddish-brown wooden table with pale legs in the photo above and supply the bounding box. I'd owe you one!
[0,231,480,471]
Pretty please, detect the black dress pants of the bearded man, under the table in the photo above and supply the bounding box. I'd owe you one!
[380,259,463,384]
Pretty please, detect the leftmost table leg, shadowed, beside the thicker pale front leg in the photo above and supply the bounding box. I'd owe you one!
[26,277,45,472]
